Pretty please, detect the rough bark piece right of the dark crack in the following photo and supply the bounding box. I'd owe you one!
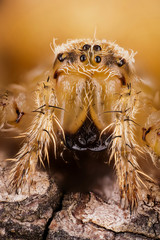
[47,193,160,240]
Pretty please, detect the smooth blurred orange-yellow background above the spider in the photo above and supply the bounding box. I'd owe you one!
[0,0,160,86]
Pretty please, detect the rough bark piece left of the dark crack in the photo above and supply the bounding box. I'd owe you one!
[0,152,62,240]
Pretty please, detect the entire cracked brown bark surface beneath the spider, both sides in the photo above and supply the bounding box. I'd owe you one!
[0,153,160,240]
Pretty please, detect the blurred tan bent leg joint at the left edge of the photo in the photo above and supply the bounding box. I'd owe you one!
[0,84,34,131]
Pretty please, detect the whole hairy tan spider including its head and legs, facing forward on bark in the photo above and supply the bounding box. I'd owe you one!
[0,39,160,209]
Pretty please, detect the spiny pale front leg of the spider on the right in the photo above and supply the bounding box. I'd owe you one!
[111,85,144,211]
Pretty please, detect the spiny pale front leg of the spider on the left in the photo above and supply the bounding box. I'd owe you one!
[10,81,63,189]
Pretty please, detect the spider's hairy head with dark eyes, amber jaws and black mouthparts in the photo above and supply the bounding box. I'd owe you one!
[53,39,134,151]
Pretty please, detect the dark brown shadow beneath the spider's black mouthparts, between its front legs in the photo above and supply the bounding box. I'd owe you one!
[48,145,116,196]
